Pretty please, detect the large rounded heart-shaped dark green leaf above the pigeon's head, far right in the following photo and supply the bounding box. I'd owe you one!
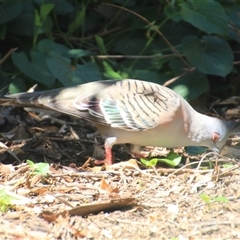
[182,36,234,77]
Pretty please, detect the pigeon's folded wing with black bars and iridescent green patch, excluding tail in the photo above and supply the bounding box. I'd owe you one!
[74,80,183,131]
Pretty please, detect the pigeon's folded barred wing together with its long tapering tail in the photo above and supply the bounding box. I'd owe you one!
[2,79,182,131]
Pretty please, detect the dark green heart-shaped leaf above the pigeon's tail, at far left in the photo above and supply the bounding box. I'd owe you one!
[12,50,55,87]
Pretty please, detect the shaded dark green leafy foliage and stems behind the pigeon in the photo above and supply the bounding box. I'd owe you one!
[0,0,240,100]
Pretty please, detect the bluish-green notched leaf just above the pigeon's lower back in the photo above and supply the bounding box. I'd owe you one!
[46,52,101,86]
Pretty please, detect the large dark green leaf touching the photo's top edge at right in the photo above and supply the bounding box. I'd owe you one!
[179,0,228,36]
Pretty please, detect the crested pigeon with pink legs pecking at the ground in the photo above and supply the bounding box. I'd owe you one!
[1,79,240,165]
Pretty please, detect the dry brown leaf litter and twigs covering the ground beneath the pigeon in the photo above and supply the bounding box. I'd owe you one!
[0,108,240,239]
